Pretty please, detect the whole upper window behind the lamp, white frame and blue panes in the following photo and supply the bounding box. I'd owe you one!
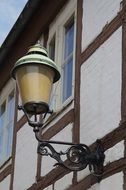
[47,0,77,110]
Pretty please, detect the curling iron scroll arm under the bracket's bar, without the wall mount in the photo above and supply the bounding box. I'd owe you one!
[38,143,88,171]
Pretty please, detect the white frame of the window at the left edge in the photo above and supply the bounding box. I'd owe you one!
[0,79,16,166]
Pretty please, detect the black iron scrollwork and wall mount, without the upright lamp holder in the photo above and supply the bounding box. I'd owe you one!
[38,136,105,174]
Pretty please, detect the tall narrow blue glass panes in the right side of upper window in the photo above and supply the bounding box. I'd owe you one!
[62,22,74,102]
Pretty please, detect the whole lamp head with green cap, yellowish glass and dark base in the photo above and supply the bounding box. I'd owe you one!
[12,44,60,114]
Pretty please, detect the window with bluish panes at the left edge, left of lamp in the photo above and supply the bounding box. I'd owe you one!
[0,85,15,164]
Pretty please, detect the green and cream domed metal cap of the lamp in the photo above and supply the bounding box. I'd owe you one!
[12,44,60,83]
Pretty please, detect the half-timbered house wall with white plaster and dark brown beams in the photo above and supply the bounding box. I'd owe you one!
[0,0,126,190]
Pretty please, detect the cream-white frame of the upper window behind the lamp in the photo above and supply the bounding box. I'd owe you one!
[47,0,77,110]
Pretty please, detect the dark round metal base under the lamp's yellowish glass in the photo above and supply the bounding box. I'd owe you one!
[24,101,49,114]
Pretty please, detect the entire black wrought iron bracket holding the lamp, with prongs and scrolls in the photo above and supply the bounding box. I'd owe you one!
[18,106,105,176]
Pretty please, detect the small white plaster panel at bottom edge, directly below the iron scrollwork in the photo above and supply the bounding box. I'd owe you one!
[54,172,73,190]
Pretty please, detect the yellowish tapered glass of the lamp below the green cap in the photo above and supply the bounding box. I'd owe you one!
[16,64,54,112]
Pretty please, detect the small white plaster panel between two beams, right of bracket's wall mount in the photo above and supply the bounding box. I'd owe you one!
[104,141,124,165]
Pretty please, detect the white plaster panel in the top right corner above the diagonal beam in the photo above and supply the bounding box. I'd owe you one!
[82,0,121,50]
